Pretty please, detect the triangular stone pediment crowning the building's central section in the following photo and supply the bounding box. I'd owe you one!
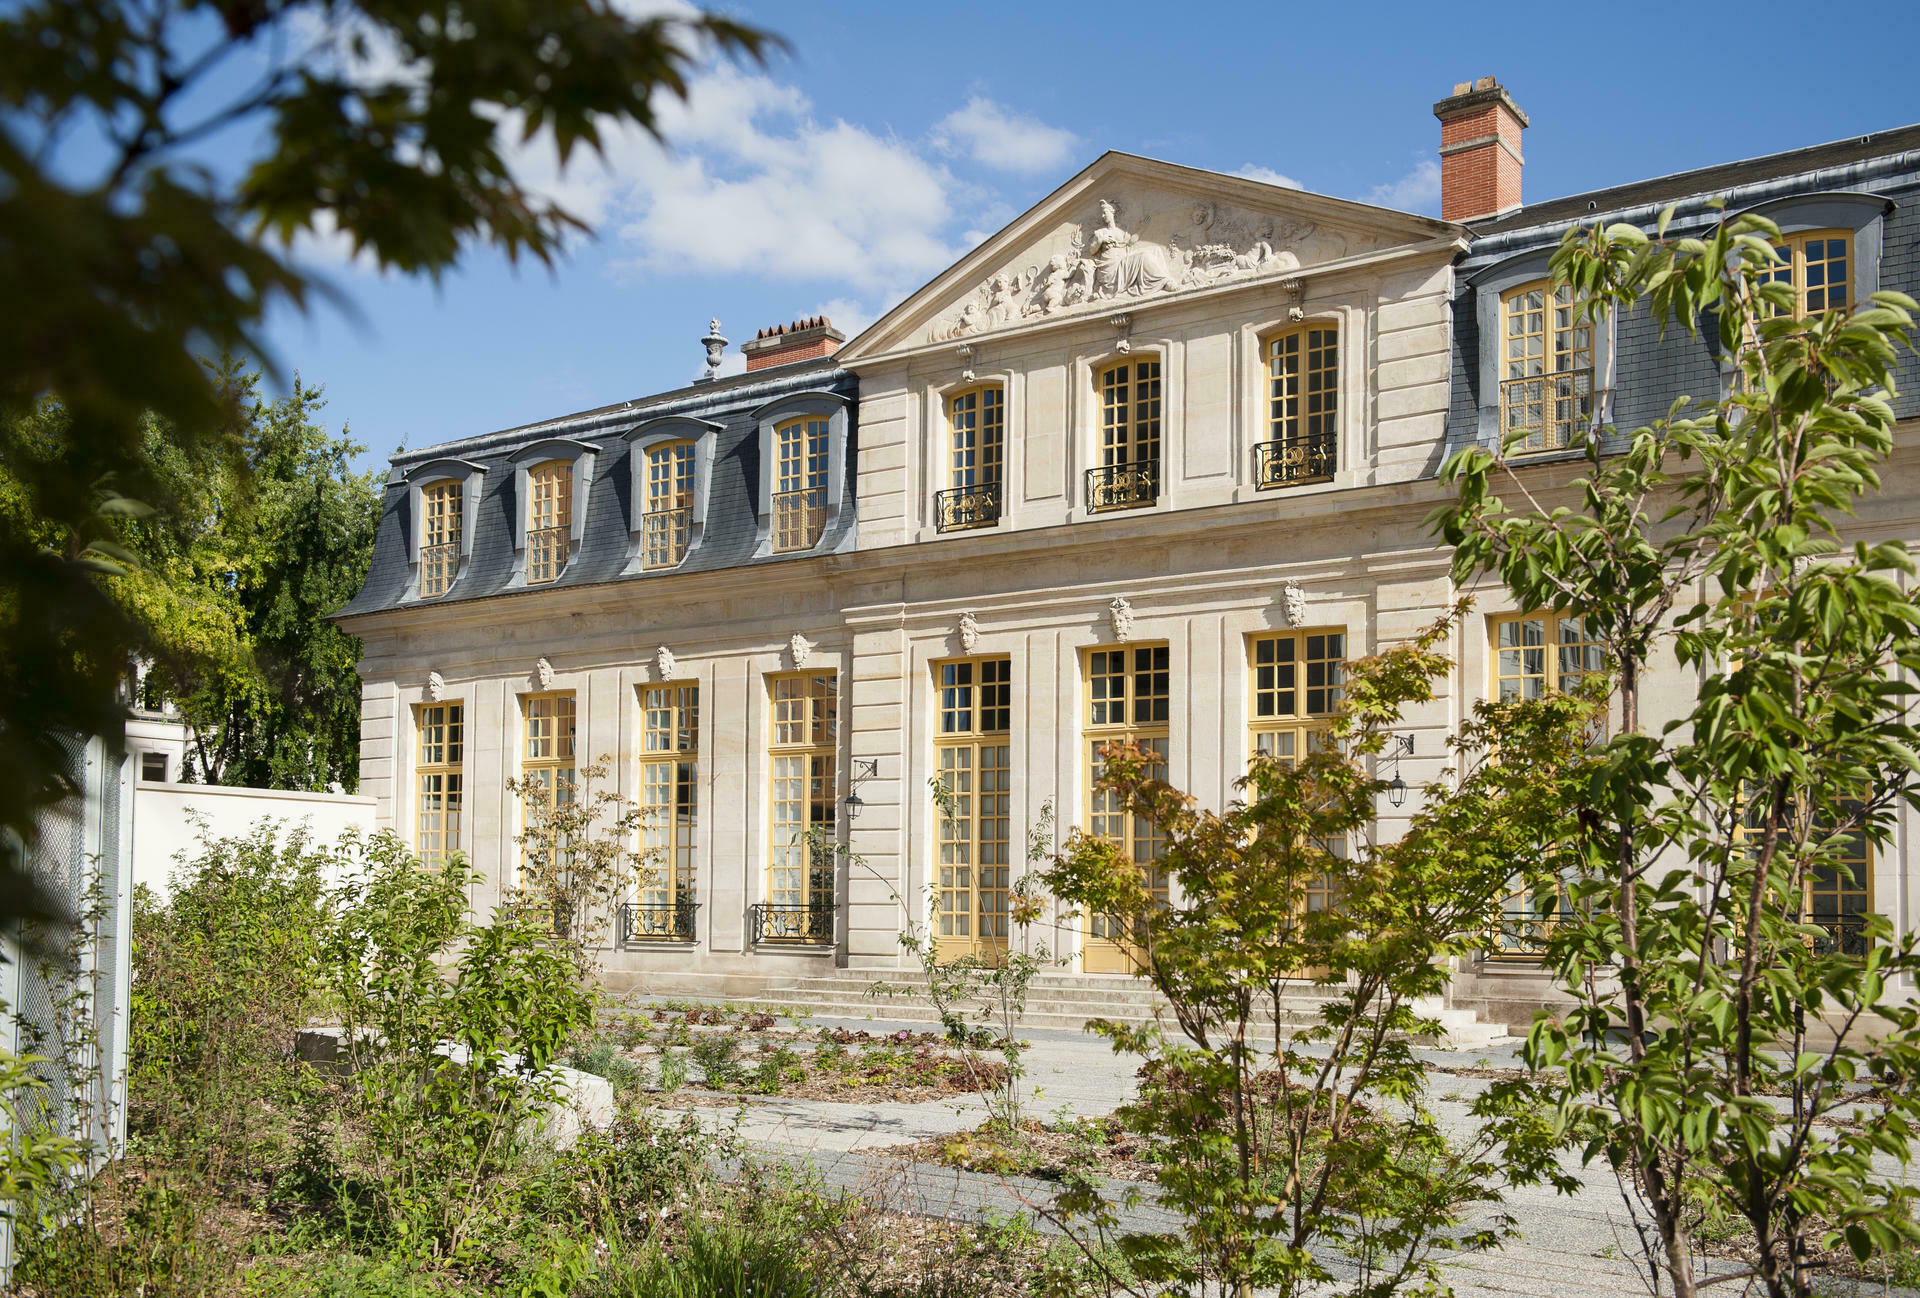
[839,154,1465,363]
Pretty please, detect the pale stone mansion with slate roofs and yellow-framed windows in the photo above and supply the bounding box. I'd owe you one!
[340,83,1920,1020]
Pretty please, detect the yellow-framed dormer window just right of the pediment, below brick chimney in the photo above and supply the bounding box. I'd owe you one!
[1500,282,1594,453]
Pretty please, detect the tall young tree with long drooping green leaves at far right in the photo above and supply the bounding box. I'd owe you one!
[1434,211,1920,1298]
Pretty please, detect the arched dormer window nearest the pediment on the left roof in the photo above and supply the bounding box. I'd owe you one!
[753,392,852,559]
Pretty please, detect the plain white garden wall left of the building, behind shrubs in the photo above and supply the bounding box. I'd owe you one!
[132,783,376,897]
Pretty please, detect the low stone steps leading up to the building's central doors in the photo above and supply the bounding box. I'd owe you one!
[753,970,1507,1050]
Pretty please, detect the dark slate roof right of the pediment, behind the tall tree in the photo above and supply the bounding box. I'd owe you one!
[1448,125,1920,457]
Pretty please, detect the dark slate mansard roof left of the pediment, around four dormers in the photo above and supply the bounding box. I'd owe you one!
[334,357,858,618]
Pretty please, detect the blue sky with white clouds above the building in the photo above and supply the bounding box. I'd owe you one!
[259,0,1920,465]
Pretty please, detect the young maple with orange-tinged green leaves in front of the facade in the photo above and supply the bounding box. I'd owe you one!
[1048,618,1594,1296]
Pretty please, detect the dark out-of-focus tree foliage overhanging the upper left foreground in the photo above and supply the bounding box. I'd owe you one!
[0,0,772,860]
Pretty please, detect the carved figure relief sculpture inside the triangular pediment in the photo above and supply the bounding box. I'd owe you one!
[929,198,1320,342]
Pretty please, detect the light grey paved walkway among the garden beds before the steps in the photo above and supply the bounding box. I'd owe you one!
[641,1016,1920,1298]
